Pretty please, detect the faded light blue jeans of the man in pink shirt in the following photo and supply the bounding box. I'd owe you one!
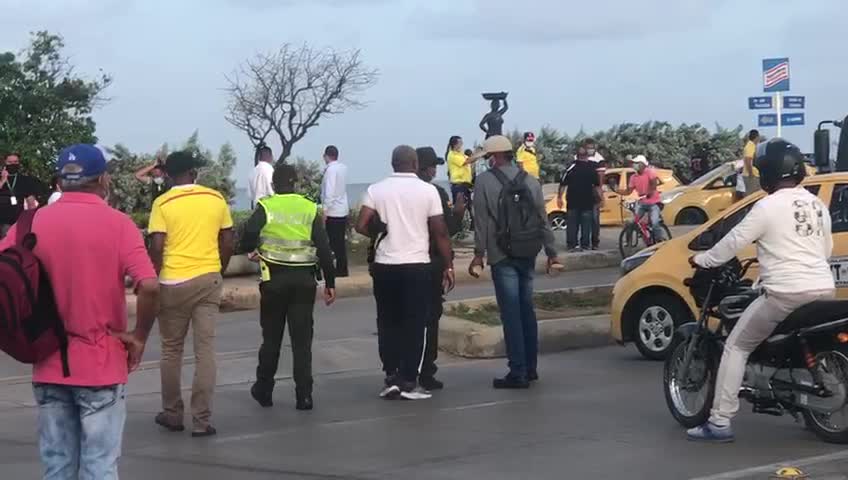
[33,383,127,480]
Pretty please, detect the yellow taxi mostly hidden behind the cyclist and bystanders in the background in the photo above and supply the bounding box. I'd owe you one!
[545,168,680,231]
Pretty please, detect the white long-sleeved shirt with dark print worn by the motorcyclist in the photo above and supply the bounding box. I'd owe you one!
[695,187,834,293]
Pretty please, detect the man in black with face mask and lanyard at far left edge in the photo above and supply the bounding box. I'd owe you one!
[0,153,45,238]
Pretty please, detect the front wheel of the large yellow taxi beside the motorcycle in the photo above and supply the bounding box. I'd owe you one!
[631,293,691,360]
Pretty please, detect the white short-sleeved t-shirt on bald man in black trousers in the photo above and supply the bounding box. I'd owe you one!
[362,173,444,265]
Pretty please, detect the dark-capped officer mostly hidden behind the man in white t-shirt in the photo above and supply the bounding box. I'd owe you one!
[415,147,465,390]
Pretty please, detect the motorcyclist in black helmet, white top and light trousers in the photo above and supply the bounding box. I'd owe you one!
[687,138,835,443]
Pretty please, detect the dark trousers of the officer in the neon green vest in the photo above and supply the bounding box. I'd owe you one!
[256,267,316,393]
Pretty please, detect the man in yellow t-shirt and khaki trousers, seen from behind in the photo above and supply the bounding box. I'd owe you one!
[147,152,233,437]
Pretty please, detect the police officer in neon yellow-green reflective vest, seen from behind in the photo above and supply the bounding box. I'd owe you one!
[242,164,336,410]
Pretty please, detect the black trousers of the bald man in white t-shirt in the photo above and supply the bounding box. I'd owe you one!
[373,263,435,382]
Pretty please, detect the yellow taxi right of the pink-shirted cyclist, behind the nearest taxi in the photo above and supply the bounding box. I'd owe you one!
[662,160,816,225]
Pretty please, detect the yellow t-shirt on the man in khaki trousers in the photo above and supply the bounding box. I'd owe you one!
[147,185,233,282]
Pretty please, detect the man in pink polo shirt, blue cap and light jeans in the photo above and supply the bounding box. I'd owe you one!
[0,145,159,480]
